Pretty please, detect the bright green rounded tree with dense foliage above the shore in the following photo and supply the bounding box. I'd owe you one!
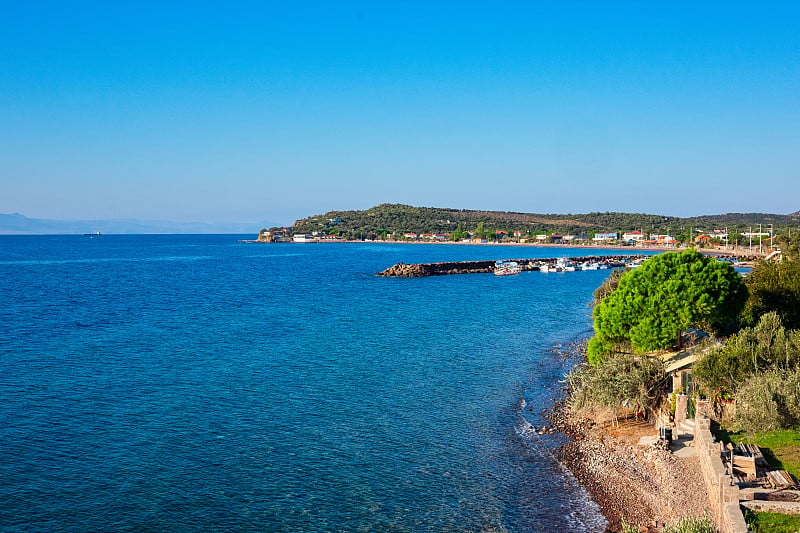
[588,249,747,363]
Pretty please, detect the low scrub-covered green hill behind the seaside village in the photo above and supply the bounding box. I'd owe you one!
[295,204,800,237]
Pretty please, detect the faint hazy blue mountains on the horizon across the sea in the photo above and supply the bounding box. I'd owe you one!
[0,213,275,235]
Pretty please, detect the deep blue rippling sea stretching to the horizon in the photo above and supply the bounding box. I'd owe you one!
[0,235,628,532]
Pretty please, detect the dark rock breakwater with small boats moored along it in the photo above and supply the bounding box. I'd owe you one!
[378,254,648,278]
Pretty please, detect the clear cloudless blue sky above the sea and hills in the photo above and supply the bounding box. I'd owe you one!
[0,0,800,223]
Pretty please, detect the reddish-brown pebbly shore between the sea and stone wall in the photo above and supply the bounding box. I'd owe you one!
[551,406,710,533]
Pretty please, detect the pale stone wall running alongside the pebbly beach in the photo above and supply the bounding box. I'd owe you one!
[694,418,748,533]
